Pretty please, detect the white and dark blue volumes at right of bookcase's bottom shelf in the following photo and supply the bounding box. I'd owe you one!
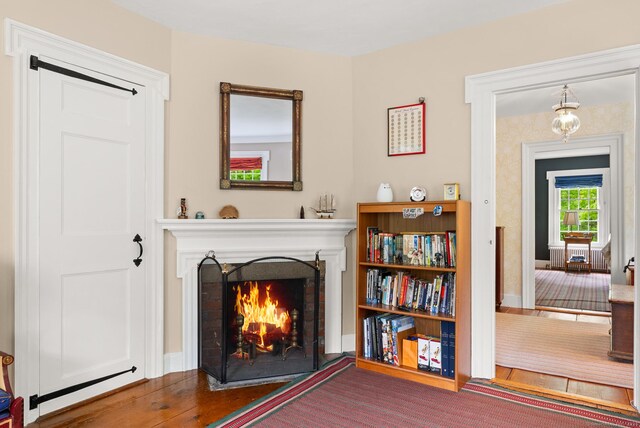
[416,321,456,378]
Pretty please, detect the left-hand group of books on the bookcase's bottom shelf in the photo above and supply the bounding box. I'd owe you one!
[363,312,416,366]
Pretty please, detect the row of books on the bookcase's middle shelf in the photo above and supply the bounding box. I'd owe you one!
[366,268,456,316]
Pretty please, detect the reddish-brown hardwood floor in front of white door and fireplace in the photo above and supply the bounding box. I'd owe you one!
[28,370,284,428]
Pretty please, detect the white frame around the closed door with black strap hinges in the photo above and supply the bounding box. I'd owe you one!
[4,18,169,423]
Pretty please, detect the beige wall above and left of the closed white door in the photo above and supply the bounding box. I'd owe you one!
[0,0,171,352]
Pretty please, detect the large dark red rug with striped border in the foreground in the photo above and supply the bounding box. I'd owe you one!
[210,357,640,428]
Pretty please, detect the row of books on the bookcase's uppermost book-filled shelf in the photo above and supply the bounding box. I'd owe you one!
[367,227,456,268]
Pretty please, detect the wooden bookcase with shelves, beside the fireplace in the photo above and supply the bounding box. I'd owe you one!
[356,200,471,391]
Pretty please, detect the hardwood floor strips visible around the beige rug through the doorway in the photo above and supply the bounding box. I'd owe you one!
[493,307,638,416]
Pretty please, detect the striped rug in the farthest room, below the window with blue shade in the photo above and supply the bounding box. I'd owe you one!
[536,269,611,312]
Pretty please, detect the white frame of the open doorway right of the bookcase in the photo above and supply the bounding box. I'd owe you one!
[465,45,640,401]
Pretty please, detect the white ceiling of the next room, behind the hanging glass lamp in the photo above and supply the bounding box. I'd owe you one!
[496,74,635,117]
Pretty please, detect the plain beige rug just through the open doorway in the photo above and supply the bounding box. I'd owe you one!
[496,312,633,388]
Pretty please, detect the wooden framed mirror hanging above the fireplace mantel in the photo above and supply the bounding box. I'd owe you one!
[220,82,302,191]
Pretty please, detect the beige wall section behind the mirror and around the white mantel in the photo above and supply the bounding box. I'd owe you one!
[165,32,354,352]
